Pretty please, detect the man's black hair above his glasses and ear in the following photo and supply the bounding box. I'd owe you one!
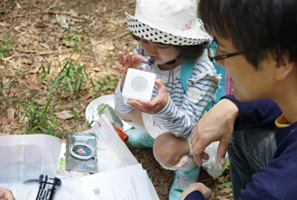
[199,0,297,67]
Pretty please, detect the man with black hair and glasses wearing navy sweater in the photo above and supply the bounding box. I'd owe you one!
[182,0,297,200]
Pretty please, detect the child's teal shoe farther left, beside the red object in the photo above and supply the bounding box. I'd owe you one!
[126,128,155,149]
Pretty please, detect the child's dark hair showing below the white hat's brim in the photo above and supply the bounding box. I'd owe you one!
[131,33,209,59]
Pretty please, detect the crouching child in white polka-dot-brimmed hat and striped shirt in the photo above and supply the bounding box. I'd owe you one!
[113,0,220,200]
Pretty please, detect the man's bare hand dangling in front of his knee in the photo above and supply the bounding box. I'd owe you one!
[191,98,239,166]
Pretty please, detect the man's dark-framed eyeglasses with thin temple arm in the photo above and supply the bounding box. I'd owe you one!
[207,40,245,63]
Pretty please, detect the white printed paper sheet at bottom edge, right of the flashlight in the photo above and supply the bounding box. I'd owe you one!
[82,164,152,200]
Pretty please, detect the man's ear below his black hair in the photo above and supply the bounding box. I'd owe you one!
[274,54,295,81]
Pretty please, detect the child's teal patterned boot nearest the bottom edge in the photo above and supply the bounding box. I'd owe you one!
[169,166,200,200]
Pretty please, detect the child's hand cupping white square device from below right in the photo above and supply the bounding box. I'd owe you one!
[128,79,169,114]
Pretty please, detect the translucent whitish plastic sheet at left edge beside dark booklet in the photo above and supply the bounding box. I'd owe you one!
[0,134,61,183]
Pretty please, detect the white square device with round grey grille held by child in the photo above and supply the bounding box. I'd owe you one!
[122,68,156,101]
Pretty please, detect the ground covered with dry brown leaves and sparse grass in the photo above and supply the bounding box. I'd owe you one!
[0,0,232,200]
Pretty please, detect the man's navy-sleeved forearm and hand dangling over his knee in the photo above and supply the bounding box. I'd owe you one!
[191,95,281,166]
